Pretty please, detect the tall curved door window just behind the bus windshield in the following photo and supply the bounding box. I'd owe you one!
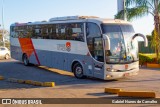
[86,22,104,62]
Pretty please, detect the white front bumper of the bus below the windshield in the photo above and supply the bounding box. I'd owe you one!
[105,68,139,80]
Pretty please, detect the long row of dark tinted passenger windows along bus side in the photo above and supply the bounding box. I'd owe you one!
[11,23,84,42]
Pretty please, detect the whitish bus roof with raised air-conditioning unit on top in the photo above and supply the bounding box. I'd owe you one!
[11,16,131,26]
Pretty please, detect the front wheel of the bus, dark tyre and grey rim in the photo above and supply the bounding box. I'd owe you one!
[73,63,85,79]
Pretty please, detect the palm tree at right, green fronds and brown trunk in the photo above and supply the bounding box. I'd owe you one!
[115,0,160,62]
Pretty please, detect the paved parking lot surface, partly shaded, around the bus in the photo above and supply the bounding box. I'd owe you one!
[0,59,160,106]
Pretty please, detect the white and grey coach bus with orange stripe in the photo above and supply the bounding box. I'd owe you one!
[10,16,148,80]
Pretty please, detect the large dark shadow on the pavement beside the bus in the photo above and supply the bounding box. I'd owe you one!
[0,59,116,89]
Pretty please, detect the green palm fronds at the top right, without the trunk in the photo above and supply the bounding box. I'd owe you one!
[115,0,156,20]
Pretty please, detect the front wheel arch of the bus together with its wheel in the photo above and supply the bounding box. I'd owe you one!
[72,61,85,79]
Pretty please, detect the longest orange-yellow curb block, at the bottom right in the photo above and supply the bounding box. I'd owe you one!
[118,91,156,98]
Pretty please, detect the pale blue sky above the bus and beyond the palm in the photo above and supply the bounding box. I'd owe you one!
[0,0,154,35]
